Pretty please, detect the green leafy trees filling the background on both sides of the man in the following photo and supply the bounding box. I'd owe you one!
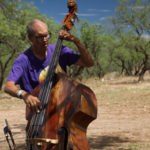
[0,0,150,89]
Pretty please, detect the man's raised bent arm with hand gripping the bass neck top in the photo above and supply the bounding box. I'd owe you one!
[60,30,94,67]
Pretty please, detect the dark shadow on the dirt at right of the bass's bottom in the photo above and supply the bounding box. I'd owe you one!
[88,136,131,149]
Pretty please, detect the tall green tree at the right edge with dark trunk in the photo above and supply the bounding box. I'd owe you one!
[111,0,150,79]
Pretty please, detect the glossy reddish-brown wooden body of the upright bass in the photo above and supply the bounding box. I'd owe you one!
[27,73,97,150]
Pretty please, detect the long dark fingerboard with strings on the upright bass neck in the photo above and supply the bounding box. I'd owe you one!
[33,32,63,126]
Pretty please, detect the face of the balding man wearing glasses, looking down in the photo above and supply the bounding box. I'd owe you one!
[29,22,49,51]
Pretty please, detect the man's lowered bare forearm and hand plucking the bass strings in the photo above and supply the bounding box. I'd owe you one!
[4,81,41,113]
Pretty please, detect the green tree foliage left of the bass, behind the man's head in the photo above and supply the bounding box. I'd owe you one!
[0,0,54,89]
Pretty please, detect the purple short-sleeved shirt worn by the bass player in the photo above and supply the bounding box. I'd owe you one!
[8,44,80,93]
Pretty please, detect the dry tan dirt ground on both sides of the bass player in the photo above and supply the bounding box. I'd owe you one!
[0,77,150,150]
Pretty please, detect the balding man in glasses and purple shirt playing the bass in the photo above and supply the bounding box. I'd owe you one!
[4,19,93,113]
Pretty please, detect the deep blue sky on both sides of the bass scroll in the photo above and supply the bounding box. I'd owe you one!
[28,0,117,24]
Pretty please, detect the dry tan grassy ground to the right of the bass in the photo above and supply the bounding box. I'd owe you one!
[84,76,150,150]
